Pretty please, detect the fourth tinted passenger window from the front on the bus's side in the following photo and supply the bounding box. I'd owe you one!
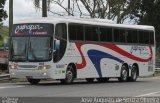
[114,29,126,43]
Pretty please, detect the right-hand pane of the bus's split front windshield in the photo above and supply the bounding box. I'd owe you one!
[28,37,51,61]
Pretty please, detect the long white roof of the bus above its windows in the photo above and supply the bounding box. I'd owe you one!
[15,17,155,30]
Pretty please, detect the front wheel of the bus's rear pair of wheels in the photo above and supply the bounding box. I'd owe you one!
[118,65,128,82]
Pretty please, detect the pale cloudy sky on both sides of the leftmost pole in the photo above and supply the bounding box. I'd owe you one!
[4,0,40,25]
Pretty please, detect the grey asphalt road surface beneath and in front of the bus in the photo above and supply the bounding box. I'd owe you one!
[0,78,160,97]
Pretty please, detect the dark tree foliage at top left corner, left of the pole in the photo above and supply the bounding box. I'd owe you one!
[0,0,8,24]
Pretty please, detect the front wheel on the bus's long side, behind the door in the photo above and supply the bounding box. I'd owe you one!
[60,65,75,84]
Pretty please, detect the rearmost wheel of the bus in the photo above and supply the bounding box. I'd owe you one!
[129,65,138,82]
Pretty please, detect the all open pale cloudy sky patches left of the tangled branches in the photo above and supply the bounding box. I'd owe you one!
[3,0,70,26]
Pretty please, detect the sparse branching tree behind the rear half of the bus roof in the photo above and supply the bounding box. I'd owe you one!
[80,0,141,23]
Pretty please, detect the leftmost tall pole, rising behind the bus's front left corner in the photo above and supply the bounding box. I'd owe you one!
[9,0,13,35]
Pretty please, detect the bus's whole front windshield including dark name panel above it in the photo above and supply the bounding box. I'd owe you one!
[10,24,54,62]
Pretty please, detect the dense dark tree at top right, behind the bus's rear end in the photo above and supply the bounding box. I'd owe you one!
[139,0,160,46]
